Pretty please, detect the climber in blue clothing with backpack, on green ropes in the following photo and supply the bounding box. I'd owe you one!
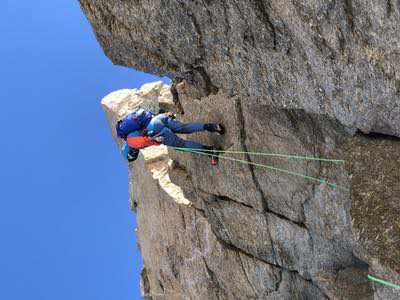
[116,109,225,164]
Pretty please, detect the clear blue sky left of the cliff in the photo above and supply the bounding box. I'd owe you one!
[0,0,166,300]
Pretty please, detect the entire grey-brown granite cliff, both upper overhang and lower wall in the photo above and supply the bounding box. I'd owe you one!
[80,0,400,299]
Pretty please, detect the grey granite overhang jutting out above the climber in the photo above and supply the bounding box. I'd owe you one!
[80,0,400,136]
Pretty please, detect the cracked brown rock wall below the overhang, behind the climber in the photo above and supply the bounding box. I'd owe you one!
[102,84,400,299]
